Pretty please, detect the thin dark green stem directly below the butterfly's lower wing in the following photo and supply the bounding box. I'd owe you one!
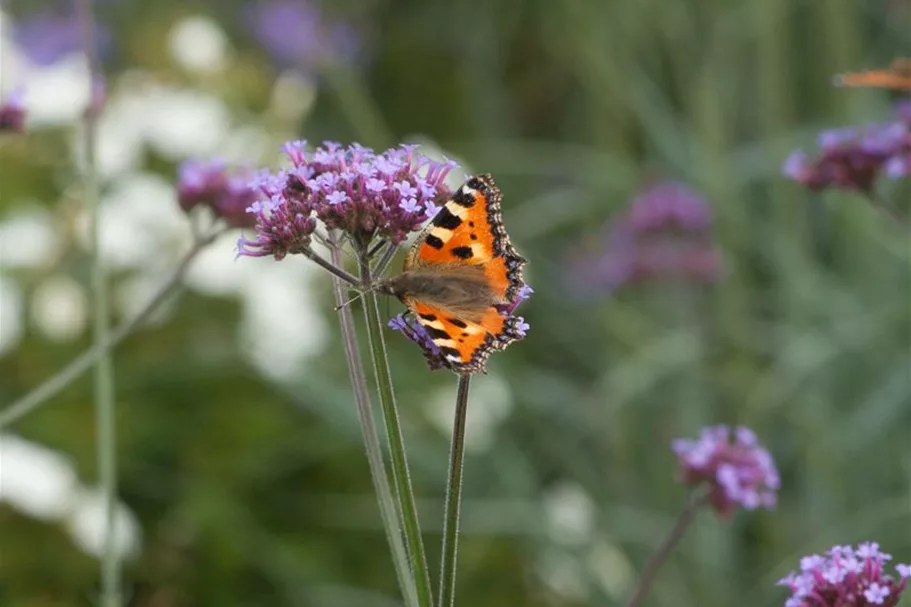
[437,373,471,607]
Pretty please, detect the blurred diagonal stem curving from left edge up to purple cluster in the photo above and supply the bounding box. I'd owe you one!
[0,231,222,430]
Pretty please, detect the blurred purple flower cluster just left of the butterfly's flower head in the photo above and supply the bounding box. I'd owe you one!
[177,160,257,228]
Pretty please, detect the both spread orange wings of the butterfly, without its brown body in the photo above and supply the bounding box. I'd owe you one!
[404,174,525,373]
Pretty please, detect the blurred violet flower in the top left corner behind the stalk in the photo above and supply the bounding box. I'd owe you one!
[13,10,110,65]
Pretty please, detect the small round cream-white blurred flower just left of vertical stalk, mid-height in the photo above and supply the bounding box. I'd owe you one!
[31,275,88,341]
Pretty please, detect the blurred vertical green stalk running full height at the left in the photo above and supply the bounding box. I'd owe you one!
[76,0,121,607]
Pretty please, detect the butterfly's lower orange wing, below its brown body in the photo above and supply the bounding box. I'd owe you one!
[407,300,520,373]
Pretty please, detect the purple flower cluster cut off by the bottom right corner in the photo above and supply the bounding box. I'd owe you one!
[778,542,911,607]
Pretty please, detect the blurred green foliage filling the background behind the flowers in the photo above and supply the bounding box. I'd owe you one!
[0,0,911,607]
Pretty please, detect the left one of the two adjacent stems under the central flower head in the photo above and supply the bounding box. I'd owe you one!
[330,238,420,607]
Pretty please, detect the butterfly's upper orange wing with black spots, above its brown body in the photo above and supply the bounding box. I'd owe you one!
[405,174,525,303]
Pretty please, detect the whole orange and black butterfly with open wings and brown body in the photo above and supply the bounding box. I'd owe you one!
[378,174,526,373]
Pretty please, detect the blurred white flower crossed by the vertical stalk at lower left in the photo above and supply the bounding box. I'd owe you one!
[66,489,142,557]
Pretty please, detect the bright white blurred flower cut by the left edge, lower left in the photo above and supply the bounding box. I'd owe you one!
[0,434,78,521]
